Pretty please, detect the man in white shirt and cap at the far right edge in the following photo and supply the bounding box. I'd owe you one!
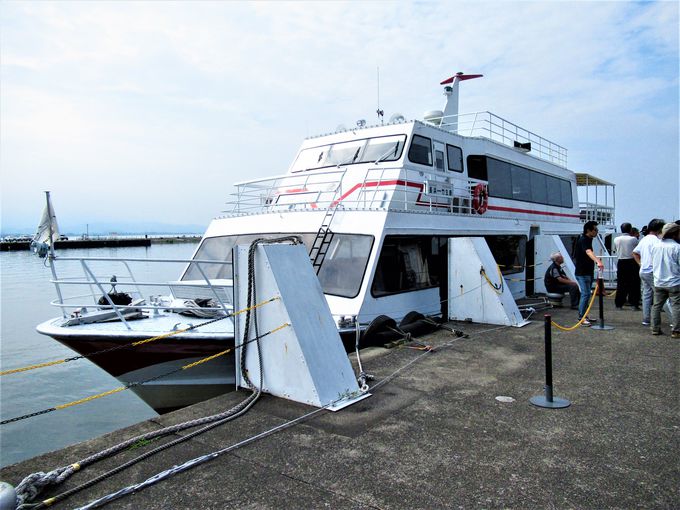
[652,223,680,338]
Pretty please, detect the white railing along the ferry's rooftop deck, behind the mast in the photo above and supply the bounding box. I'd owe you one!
[428,112,567,167]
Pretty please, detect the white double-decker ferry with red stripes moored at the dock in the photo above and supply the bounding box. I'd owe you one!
[37,73,614,412]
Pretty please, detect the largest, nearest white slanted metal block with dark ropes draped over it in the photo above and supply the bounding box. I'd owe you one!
[233,244,369,410]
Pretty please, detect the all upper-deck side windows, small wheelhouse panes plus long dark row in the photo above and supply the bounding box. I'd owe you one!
[408,135,573,208]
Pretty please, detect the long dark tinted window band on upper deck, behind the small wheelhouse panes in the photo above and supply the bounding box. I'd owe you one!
[467,156,573,208]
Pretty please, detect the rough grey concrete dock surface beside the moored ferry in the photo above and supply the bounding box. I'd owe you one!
[0,298,680,509]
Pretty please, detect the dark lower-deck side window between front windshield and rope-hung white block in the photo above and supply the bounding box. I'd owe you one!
[371,236,439,297]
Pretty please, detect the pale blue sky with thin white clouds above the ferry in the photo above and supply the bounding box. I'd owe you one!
[0,0,680,233]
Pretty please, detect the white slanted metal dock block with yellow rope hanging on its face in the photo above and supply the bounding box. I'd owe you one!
[448,237,529,327]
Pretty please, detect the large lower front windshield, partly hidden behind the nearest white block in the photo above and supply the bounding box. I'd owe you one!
[182,233,373,298]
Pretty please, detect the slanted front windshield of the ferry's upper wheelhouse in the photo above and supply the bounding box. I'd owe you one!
[292,135,406,172]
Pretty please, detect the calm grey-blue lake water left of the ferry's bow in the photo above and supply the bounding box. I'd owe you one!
[0,243,196,471]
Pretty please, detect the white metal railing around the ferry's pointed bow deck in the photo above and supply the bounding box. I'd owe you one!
[50,257,233,330]
